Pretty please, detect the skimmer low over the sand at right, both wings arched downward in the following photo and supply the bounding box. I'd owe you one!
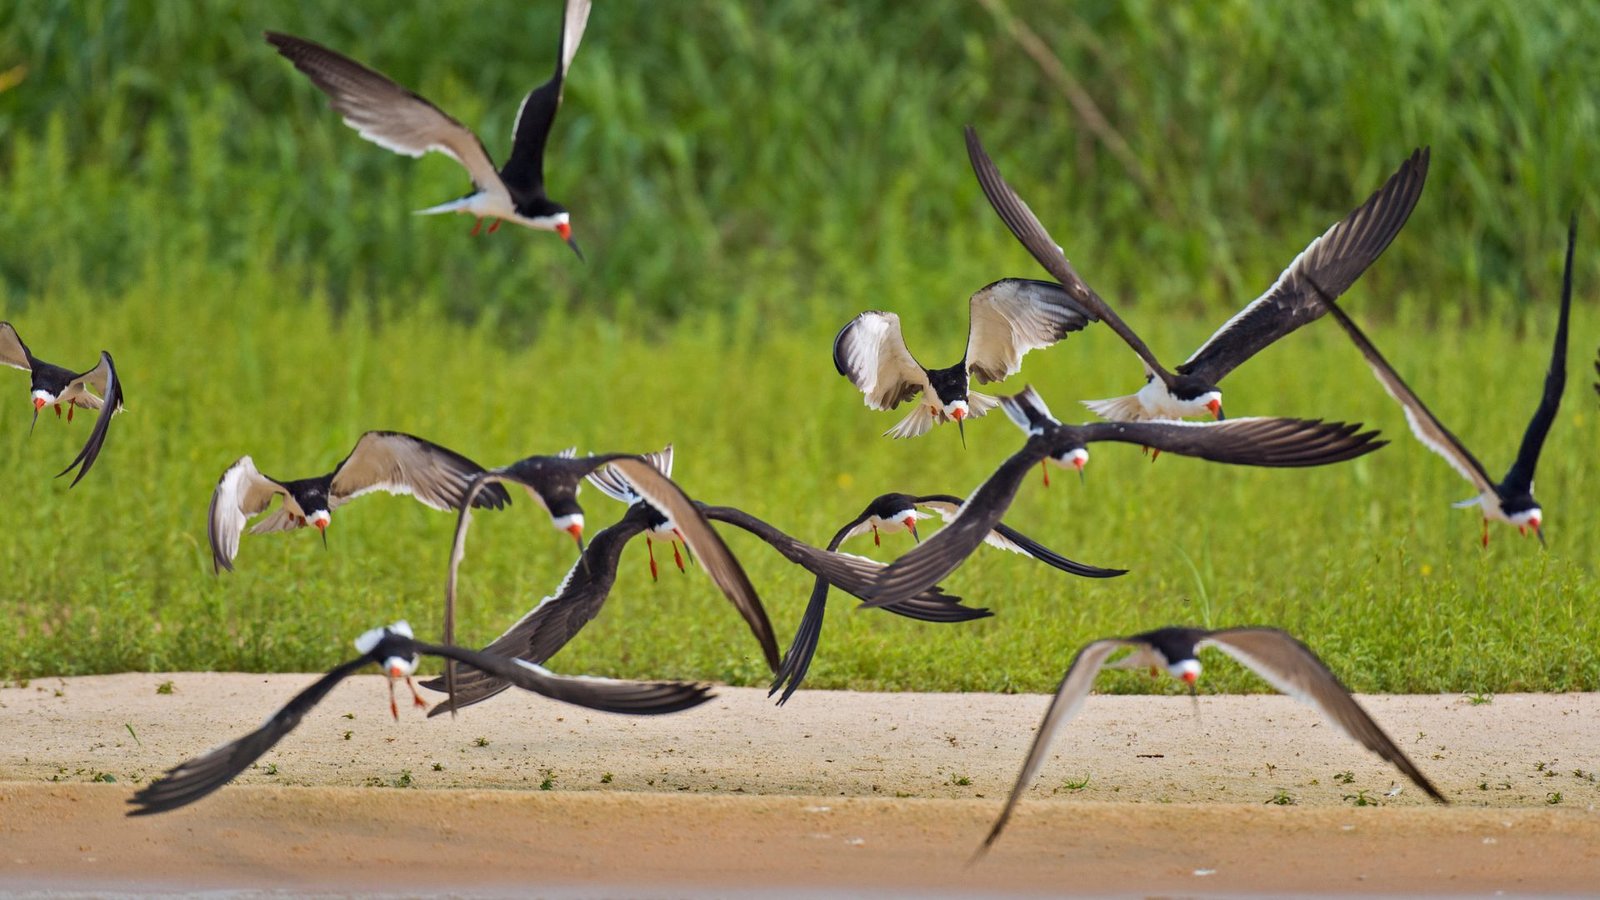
[978,628,1450,855]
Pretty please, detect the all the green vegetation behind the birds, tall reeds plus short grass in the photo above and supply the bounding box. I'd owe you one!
[0,0,1600,688]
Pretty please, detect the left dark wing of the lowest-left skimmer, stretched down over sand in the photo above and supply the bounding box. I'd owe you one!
[128,657,368,815]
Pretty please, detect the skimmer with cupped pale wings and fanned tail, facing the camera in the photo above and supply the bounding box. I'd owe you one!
[834,279,1099,442]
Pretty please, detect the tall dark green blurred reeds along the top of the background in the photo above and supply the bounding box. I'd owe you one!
[0,0,1600,325]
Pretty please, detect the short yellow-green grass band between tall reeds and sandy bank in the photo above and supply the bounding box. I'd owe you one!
[0,266,1600,693]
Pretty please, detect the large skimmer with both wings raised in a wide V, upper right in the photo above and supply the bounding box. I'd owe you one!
[966,125,1429,421]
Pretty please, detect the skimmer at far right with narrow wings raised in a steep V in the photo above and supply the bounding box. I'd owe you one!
[1323,213,1578,546]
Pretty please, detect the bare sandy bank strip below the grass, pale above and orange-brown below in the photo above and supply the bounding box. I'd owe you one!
[0,673,1600,897]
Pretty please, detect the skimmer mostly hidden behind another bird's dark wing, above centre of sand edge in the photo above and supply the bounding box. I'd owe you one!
[766,493,1128,706]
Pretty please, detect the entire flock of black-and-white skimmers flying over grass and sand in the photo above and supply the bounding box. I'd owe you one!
[0,0,1600,849]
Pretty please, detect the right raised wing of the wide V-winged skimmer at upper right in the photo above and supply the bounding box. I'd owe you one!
[1178,147,1429,384]
